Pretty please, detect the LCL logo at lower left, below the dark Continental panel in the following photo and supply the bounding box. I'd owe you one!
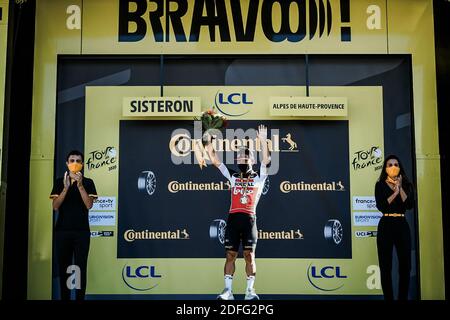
[122,265,162,291]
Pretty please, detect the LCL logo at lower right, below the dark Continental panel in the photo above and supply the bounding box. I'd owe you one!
[308,265,347,291]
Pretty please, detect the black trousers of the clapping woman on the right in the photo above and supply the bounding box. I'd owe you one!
[377,216,411,300]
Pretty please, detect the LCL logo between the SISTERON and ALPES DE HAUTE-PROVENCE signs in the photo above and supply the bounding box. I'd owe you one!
[214,92,253,117]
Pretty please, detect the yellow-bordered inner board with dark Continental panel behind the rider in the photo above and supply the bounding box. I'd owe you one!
[78,86,383,295]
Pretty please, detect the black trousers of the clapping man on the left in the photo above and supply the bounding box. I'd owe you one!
[55,231,91,300]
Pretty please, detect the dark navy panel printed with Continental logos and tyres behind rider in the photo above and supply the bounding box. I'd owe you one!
[117,120,352,258]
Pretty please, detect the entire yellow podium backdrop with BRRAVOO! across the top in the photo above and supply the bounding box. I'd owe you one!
[27,0,445,299]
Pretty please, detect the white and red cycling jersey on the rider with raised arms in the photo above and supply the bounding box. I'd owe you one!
[219,163,267,214]
